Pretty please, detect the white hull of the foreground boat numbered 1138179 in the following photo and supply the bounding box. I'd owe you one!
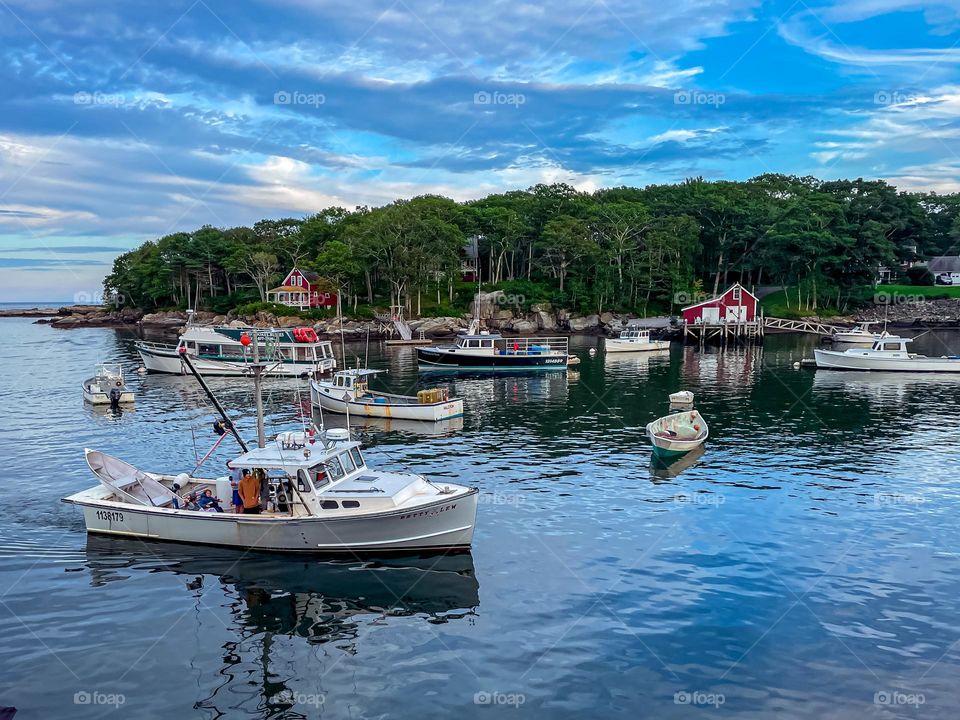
[65,488,478,553]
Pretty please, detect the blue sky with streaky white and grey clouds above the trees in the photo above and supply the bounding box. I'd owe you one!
[0,0,960,302]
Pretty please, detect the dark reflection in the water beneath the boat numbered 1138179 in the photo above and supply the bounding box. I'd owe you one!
[80,536,480,717]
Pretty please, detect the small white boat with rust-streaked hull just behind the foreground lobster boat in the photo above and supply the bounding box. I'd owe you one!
[310,369,463,422]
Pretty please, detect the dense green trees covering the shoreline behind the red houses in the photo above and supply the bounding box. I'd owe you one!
[104,174,960,315]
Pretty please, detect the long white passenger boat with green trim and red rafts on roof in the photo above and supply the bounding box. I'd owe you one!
[136,315,337,377]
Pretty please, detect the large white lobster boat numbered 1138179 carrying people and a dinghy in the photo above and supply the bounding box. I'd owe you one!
[63,332,478,553]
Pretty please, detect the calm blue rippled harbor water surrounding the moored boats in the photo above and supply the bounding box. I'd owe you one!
[0,319,960,719]
